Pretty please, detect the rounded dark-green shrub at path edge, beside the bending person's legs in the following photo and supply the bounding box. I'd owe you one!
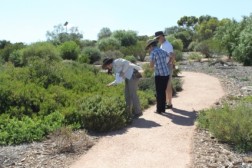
[76,95,126,132]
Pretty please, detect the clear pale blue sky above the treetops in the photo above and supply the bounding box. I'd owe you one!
[0,0,252,44]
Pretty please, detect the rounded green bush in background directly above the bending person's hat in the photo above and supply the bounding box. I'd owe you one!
[97,37,121,51]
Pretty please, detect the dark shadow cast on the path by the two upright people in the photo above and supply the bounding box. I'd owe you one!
[161,108,196,126]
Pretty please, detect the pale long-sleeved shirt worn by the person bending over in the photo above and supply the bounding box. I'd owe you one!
[112,58,142,84]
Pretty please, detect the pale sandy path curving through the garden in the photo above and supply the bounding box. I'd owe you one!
[70,72,224,168]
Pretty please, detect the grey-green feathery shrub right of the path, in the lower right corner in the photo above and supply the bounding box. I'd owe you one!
[197,101,252,152]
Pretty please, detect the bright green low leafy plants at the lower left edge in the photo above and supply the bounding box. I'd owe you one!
[0,112,64,145]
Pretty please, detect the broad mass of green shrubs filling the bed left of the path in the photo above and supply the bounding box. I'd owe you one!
[0,58,154,144]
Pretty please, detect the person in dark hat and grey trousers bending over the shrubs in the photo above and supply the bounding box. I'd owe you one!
[102,58,143,118]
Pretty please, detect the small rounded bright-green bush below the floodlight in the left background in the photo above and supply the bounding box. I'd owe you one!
[60,41,80,60]
